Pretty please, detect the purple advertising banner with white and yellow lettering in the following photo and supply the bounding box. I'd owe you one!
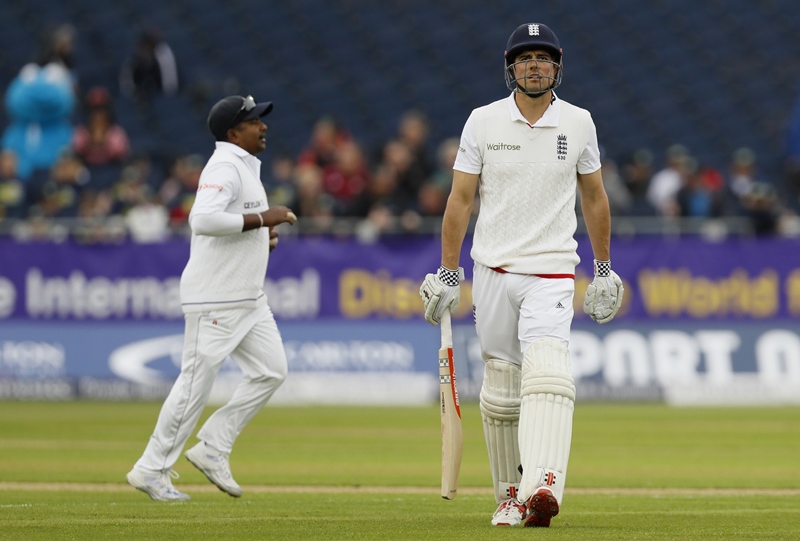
[0,237,800,324]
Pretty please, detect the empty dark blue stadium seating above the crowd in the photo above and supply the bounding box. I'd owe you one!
[0,0,800,187]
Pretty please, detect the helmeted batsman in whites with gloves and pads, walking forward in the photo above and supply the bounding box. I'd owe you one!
[420,23,623,527]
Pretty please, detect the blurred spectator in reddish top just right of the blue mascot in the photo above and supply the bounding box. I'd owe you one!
[72,87,130,168]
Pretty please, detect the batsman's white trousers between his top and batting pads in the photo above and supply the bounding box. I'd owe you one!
[472,263,575,366]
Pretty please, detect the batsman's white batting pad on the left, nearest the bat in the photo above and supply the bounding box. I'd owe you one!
[480,359,521,503]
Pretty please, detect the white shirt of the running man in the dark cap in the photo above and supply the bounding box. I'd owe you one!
[181,141,269,313]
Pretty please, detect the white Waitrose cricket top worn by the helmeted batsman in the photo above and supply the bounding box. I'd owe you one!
[453,92,600,274]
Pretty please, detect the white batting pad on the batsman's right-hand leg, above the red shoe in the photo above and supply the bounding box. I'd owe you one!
[519,339,575,505]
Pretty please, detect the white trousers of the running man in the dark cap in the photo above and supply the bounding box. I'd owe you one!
[135,298,287,471]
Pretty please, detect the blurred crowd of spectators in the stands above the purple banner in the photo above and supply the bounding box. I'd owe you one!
[0,25,800,242]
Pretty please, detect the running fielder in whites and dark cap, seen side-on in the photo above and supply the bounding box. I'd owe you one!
[127,96,297,501]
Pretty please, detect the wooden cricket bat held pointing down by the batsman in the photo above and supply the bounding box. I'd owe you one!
[439,310,464,500]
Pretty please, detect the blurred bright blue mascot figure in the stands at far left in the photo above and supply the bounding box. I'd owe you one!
[2,63,75,180]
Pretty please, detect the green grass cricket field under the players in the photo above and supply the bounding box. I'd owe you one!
[0,402,800,541]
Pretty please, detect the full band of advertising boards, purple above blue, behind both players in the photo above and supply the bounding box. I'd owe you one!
[0,236,800,405]
